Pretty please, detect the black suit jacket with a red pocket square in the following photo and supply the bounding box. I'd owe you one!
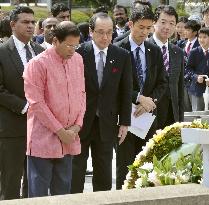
[77,42,132,141]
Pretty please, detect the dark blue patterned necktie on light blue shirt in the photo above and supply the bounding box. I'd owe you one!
[135,47,144,90]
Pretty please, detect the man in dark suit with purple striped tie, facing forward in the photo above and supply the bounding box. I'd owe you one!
[149,5,184,129]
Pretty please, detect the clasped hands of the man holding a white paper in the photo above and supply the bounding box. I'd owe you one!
[134,95,157,117]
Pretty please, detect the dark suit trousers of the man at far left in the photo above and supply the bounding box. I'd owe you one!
[0,137,26,200]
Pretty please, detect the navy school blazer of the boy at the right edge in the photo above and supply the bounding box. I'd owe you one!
[184,46,209,97]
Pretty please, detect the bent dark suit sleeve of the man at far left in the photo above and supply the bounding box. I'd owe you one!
[0,64,27,114]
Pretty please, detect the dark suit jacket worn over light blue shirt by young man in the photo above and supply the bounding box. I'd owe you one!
[115,37,167,108]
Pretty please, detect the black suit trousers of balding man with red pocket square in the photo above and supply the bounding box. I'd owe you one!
[71,117,114,193]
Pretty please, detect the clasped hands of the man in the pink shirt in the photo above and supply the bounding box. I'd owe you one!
[56,125,80,144]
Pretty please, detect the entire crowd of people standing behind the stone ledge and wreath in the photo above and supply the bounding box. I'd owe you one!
[0,0,209,200]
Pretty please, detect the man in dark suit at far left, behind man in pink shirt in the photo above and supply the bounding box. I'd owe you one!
[0,7,43,200]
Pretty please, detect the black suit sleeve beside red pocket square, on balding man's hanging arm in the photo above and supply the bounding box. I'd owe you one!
[119,52,133,126]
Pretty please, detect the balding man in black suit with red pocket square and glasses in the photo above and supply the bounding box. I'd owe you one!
[71,13,132,193]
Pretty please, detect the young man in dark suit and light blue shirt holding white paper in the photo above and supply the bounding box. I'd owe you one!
[115,7,167,189]
